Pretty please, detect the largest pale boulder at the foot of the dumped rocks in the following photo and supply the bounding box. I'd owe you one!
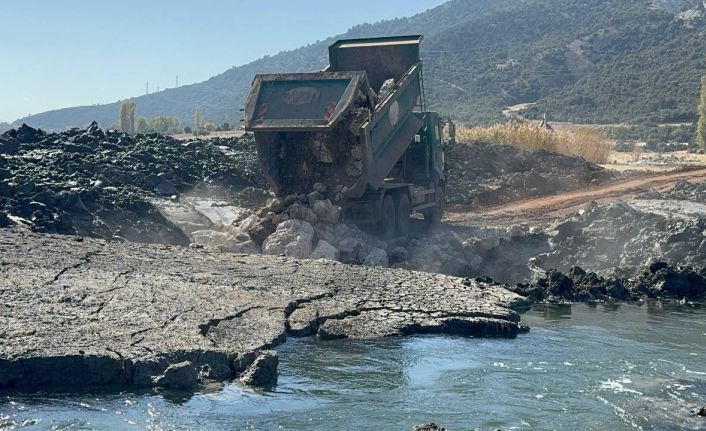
[262,220,314,259]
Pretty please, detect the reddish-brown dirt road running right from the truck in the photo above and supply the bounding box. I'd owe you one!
[445,167,706,225]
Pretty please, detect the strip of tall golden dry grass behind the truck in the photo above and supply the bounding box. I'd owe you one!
[456,123,612,164]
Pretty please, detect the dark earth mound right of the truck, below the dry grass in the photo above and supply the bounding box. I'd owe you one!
[445,142,620,209]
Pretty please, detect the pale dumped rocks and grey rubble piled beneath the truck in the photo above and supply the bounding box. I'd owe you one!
[191,197,550,283]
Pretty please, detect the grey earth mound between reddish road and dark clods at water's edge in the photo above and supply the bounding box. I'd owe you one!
[533,200,706,276]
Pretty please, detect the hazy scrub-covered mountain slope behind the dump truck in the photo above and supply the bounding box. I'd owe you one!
[9,0,706,129]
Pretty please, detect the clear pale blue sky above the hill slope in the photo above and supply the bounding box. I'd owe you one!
[0,0,444,121]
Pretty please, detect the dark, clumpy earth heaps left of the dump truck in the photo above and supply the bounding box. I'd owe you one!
[0,122,266,244]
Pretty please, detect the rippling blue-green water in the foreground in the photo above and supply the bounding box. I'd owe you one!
[0,303,706,430]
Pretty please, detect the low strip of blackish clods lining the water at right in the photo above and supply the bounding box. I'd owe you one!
[508,261,706,303]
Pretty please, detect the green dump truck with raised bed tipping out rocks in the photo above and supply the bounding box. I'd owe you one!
[244,36,446,237]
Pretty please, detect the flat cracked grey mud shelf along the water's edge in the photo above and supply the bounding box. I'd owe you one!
[0,229,526,389]
